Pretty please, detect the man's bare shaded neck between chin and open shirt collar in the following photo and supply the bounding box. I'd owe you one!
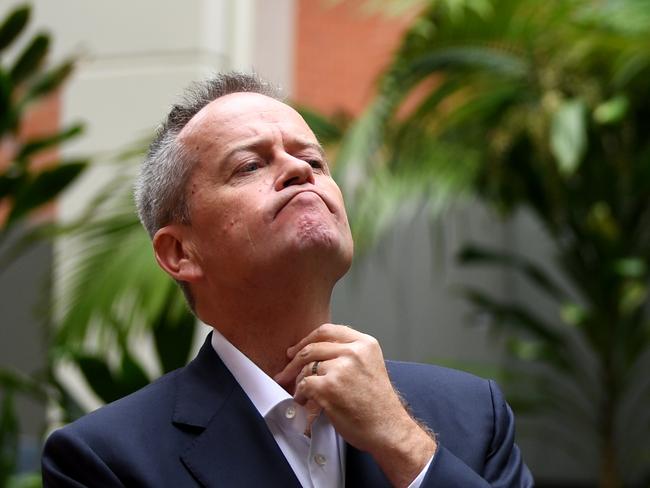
[200,276,333,377]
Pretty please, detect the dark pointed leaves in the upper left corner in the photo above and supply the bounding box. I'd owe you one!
[0,6,87,255]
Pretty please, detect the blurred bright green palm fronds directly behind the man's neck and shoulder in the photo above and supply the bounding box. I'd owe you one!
[50,138,196,416]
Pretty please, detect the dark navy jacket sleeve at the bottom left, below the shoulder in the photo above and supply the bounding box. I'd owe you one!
[42,429,124,488]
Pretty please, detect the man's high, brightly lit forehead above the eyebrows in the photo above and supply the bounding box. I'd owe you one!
[178,93,316,149]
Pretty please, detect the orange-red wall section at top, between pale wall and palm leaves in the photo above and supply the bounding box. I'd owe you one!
[293,0,413,115]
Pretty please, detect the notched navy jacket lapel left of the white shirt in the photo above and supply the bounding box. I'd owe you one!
[172,335,300,487]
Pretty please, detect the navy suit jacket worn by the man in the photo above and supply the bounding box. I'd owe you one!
[43,336,533,488]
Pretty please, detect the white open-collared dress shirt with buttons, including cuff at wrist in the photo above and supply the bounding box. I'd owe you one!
[212,329,431,488]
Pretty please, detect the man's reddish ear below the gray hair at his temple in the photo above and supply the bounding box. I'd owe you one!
[153,224,203,283]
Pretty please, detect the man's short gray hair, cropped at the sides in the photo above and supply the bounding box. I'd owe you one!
[135,72,283,310]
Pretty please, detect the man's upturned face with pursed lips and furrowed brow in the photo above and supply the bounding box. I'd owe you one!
[179,93,352,286]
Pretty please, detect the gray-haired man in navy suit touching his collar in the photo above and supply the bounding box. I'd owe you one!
[43,73,532,487]
